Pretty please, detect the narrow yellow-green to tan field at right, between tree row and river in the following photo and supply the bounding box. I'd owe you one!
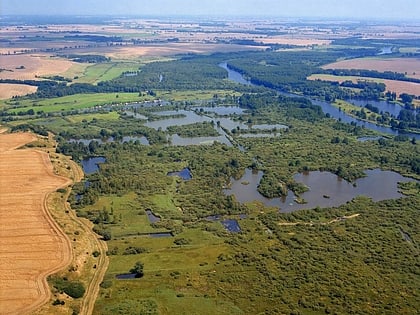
[308,74,420,95]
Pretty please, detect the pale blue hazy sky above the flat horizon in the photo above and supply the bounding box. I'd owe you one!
[0,0,420,20]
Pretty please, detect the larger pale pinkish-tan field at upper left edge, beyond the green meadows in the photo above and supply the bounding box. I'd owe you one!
[0,54,73,80]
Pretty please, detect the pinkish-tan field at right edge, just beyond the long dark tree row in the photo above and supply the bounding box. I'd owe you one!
[322,58,420,79]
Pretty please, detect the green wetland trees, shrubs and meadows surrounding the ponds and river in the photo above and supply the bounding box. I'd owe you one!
[1,27,420,315]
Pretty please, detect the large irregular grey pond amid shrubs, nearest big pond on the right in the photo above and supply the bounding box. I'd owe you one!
[224,169,412,212]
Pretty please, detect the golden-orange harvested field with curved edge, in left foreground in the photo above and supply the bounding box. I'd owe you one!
[0,133,71,314]
